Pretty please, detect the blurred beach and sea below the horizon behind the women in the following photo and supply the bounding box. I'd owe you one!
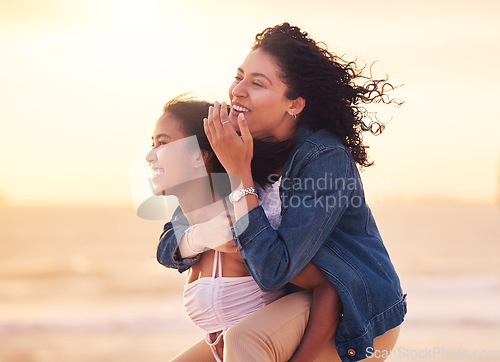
[0,201,500,362]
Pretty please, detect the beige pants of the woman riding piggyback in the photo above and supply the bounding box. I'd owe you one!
[171,291,399,362]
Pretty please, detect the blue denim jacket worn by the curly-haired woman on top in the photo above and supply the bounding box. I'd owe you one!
[157,127,406,361]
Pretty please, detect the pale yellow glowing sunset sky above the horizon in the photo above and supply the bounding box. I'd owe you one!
[0,0,500,205]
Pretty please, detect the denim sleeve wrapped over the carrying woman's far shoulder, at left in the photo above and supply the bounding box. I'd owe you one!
[156,207,201,273]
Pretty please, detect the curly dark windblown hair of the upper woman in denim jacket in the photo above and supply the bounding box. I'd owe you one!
[252,23,402,167]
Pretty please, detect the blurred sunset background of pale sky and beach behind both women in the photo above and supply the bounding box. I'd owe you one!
[0,0,500,362]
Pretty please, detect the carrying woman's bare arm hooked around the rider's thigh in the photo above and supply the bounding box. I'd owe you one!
[290,262,342,362]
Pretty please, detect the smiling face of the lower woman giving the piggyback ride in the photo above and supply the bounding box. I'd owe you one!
[146,112,207,196]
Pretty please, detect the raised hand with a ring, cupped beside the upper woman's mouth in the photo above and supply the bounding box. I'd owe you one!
[203,102,253,176]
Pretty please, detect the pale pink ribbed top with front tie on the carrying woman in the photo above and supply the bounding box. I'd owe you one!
[184,251,284,361]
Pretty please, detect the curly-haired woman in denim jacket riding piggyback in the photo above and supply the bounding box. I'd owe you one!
[158,23,406,361]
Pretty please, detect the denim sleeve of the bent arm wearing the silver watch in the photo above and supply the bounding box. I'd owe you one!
[231,145,356,291]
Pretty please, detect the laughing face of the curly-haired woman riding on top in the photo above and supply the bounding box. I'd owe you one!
[229,49,303,139]
